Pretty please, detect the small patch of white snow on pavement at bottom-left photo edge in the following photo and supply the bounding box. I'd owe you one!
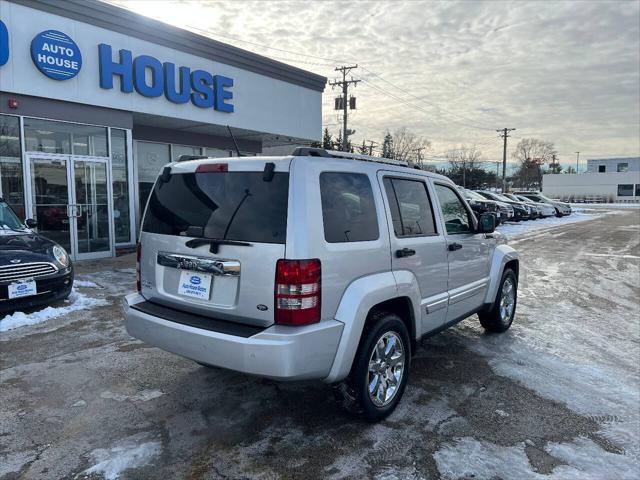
[82,433,161,480]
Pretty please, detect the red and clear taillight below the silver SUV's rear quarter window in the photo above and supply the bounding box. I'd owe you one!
[275,258,321,326]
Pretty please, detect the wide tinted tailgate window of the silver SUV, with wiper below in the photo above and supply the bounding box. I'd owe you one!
[142,172,289,243]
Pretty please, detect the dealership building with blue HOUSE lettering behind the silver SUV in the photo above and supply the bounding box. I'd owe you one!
[0,0,326,259]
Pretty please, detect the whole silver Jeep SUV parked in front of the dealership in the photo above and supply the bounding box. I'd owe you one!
[124,148,518,420]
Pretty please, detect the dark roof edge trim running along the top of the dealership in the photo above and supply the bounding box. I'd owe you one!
[7,0,327,92]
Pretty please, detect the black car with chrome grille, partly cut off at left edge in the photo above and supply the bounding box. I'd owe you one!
[0,198,73,312]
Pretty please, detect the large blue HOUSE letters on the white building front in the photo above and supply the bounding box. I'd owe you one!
[98,43,234,113]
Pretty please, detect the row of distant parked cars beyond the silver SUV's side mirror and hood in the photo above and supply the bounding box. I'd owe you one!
[458,187,571,224]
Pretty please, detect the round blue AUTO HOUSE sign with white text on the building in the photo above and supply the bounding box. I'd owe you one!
[31,30,82,80]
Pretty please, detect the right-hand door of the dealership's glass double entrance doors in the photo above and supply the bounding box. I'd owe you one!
[70,157,112,259]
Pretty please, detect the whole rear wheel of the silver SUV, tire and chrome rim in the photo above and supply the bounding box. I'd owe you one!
[335,312,411,422]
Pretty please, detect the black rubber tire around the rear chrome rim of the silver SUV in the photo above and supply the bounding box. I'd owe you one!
[334,312,411,422]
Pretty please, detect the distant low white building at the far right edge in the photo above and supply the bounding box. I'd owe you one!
[542,157,640,203]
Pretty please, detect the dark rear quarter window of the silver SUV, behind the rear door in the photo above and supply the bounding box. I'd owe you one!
[320,172,378,243]
